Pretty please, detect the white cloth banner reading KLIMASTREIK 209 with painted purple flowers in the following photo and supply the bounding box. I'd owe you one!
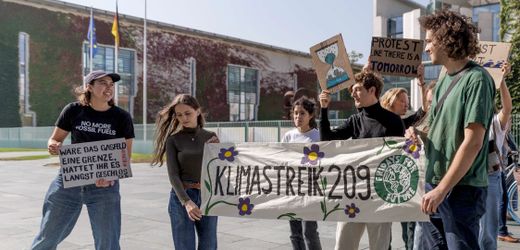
[200,137,428,222]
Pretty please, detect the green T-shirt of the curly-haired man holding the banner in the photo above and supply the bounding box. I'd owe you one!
[424,62,495,187]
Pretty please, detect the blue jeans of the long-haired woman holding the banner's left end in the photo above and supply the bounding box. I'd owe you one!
[168,188,218,250]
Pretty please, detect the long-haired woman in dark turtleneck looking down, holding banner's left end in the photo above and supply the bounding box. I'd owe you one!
[152,94,219,250]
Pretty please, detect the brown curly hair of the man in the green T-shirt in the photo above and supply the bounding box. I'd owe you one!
[419,10,480,60]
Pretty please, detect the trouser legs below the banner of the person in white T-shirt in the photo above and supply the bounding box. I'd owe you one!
[289,220,321,250]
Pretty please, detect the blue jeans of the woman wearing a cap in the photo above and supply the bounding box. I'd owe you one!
[31,174,121,250]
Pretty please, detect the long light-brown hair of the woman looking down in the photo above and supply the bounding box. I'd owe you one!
[152,94,205,166]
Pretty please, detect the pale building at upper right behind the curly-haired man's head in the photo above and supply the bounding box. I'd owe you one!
[373,0,500,110]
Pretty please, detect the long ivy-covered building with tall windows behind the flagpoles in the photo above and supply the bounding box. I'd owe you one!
[0,0,360,127]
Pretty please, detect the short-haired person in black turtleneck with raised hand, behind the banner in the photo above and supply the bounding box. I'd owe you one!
[320,71,404,250]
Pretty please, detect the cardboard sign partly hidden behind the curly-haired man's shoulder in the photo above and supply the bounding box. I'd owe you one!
[473,41,511,89]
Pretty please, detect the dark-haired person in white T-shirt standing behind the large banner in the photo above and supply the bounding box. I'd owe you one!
[282,96,321,250]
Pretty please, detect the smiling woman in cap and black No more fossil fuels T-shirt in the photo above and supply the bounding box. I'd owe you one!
[31,71,134,250]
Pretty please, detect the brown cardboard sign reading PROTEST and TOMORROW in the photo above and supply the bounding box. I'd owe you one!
[370,37,424,77]
